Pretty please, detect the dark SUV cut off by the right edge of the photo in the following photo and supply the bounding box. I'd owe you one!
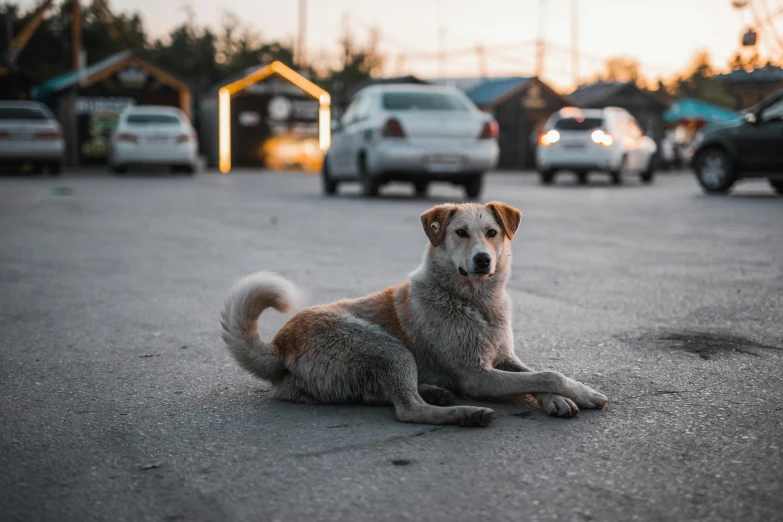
[692,90,783,195]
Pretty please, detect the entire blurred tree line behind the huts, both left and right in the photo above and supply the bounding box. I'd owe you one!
[0,0,771,109]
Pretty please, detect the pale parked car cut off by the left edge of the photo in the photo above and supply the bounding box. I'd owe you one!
[0,101,65,175]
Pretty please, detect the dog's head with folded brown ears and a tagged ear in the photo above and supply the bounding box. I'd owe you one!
[421,201,522,279]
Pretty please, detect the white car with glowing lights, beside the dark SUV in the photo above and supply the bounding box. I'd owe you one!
[536,107,657,185]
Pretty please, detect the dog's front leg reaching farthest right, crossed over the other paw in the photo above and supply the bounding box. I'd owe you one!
[460,368,609,409]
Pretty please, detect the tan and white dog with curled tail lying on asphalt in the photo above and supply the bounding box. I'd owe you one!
[221,202,608,426]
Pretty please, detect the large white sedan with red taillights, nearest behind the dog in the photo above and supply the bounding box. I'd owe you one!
[322,84,499,198]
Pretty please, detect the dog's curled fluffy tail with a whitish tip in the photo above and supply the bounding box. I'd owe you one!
[220,272,298,381]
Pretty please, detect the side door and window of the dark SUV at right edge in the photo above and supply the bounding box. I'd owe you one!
[737,96,783,171]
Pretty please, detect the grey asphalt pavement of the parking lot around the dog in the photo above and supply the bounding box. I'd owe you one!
[0,172,783,522]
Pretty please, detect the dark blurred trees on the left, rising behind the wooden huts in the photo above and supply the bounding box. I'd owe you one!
[0,0,383,92]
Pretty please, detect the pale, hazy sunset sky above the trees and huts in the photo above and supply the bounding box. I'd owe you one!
[19,0,783,91]
